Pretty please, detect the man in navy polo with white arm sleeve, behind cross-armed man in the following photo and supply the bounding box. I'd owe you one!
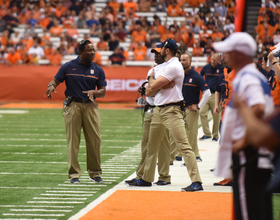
[181,53,211,161]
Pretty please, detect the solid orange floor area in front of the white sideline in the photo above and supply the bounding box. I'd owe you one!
[79,190,233,220]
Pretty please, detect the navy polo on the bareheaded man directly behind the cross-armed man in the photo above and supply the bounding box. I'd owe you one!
[182,68,209,106]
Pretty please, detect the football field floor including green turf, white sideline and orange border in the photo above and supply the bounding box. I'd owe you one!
[0,108,280,220]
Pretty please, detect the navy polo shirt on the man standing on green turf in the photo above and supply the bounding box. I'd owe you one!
[54,57,107,100]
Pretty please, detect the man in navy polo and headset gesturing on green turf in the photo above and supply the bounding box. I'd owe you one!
[45,40,107,183]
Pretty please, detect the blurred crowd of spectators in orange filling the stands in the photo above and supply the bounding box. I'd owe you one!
[0,0,280,65]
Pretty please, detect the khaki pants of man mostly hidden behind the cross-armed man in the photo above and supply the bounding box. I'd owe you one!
[136,112,171,182]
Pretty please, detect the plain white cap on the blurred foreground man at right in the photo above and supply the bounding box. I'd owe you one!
[213,32,257,57]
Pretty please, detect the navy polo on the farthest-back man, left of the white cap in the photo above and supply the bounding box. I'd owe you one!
[200,64,224,93]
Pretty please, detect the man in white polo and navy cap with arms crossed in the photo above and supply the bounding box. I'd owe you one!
[127,39,203,192]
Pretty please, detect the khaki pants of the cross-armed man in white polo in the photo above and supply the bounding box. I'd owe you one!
[143,106,201,182]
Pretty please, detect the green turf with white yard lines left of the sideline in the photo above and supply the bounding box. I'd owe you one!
[0,109,142,219]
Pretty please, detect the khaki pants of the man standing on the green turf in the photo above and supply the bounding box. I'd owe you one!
[63,102,102,179]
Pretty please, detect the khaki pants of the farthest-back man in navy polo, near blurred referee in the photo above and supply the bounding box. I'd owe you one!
[200,93,221,139]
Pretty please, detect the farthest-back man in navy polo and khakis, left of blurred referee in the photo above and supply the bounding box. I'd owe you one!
[199,53,224,141]
